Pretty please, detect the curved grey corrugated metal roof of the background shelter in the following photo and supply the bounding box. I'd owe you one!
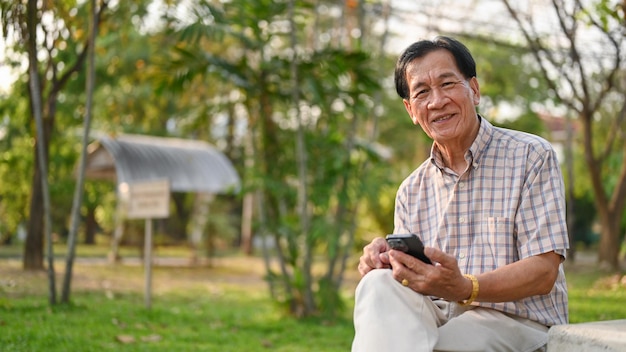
[85,134,240,193]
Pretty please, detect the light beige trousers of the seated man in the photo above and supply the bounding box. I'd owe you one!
[352,269,548,352]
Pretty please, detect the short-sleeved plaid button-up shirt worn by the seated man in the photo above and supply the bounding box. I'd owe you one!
[394,118,569,326]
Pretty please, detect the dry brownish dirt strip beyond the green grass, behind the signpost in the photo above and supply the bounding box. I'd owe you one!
[0,257,356,297]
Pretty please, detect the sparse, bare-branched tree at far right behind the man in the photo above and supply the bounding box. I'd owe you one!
[503,0,626,269]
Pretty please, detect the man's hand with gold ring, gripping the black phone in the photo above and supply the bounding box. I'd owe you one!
[388,247,472,301]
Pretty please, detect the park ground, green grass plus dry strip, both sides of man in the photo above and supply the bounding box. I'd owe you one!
[0,247,626,352]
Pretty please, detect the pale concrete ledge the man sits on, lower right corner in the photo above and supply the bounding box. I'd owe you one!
[548,319,626,352]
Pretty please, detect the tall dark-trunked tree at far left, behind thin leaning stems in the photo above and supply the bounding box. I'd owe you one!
[1,1,107,269]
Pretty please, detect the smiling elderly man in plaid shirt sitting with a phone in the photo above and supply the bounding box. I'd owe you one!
[352,37,569,352]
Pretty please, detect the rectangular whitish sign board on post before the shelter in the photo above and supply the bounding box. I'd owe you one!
[119,180,170,219]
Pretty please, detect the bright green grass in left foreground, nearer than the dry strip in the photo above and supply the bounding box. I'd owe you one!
[0,290,352,352]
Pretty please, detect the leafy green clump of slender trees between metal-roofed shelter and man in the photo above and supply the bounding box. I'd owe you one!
[163,0,388,316]
